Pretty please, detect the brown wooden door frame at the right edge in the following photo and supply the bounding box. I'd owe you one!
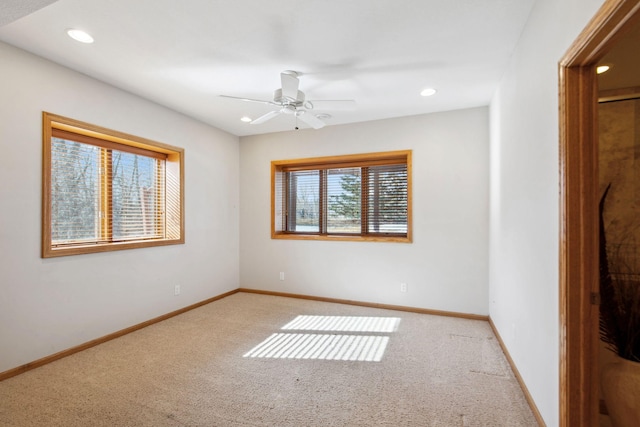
[559,0,640,427]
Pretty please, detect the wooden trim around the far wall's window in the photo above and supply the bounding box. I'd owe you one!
[271,150,413,243]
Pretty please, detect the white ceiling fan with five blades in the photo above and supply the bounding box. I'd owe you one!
[220,70,356,129]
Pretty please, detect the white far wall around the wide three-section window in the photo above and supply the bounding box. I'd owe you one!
[240,107,489,314]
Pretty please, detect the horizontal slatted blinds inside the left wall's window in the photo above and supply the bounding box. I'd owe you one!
[51,135,165,245]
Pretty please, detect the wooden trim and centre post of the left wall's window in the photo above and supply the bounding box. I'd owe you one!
[41,112,185,258]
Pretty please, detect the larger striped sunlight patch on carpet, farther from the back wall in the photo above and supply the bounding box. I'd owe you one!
[243,333,389,362]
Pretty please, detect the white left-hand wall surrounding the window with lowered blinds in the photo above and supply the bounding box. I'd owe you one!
[0,43,239,372]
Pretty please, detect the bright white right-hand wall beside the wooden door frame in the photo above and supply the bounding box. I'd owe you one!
[489,0,603,426]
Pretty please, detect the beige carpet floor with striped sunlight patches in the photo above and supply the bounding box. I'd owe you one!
[0,293,537,427]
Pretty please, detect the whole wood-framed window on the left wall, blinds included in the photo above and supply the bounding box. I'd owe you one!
[42,113,184,258]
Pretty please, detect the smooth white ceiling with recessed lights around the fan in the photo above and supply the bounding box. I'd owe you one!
[0,0,534,136]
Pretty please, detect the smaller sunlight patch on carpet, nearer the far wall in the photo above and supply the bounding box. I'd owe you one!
[282,315,400,333]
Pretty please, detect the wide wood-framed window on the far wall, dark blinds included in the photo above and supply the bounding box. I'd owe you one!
[271,151,411,242]
